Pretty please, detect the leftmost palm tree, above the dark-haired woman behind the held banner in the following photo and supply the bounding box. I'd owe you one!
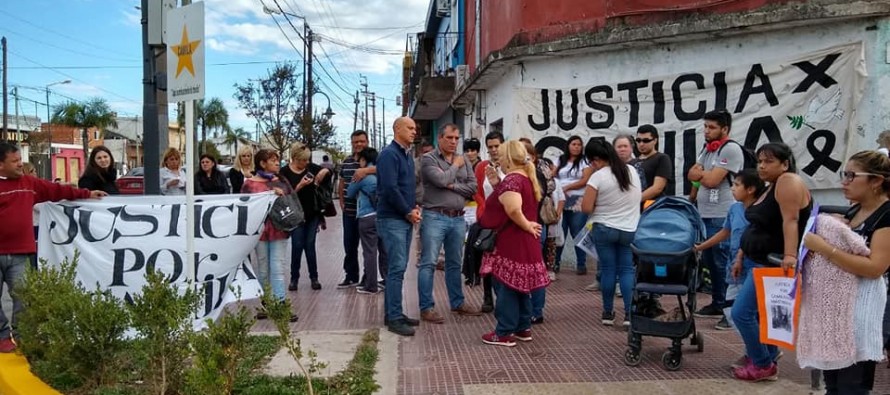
[52,97,117,158]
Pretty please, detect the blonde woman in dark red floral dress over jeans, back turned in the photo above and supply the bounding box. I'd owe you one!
[479,141,550,347]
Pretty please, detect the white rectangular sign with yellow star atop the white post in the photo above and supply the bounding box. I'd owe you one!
[164,1,205,103]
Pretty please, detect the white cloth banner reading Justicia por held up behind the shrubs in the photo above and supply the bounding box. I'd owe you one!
[38,193,275,328]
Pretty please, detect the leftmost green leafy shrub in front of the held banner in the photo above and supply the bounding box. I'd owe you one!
[14,254,130,393]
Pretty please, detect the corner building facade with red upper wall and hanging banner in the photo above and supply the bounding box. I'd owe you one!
[404,0,890,203]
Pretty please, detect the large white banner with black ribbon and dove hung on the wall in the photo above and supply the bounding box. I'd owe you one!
[511,43,866,195]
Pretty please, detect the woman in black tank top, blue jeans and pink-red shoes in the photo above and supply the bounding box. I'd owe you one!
[732,143,813,381]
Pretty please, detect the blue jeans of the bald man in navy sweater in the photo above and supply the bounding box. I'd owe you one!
[377,216,414,322]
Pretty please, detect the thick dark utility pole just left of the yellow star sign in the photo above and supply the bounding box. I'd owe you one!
[142,0,160,195]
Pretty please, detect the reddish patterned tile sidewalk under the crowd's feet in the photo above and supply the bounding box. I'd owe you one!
[254,213,890,395]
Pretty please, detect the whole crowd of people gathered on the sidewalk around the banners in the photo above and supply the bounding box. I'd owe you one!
[0,110,890,393]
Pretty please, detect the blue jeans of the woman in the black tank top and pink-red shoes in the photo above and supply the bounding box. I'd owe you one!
[732,268,779,368]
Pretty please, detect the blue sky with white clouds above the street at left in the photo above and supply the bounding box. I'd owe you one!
[0,0,429,151]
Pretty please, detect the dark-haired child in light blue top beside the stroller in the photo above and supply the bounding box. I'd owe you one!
[695,169,766,330]
